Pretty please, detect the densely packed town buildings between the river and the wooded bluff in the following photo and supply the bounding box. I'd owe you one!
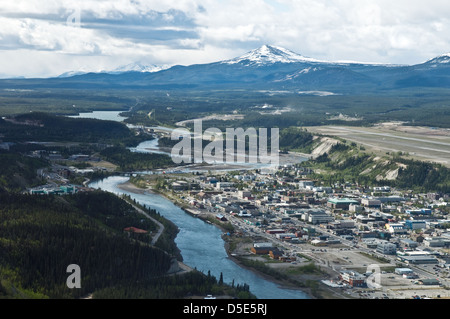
[171,167,450,272]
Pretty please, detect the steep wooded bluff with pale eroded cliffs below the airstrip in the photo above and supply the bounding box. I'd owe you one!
[303,143,450,193]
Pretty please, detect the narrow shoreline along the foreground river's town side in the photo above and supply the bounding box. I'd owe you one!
[117,181,317,299]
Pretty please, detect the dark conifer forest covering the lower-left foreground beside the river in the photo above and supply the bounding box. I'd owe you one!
[0,191,250,299]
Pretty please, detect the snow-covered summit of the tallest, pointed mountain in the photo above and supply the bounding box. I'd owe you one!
[223,44,322,65]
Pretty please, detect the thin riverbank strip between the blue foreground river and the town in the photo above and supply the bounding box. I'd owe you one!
[117,181,328,299]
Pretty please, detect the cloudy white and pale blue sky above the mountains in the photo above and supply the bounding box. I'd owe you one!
[0,0,450,77]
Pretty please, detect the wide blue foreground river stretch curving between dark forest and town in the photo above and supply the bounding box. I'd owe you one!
[89,176,310,299]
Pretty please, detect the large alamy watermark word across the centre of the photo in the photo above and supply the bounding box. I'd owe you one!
[171,120,280,169]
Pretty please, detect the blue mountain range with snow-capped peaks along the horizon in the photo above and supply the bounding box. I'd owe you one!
[0,45,450,94]
